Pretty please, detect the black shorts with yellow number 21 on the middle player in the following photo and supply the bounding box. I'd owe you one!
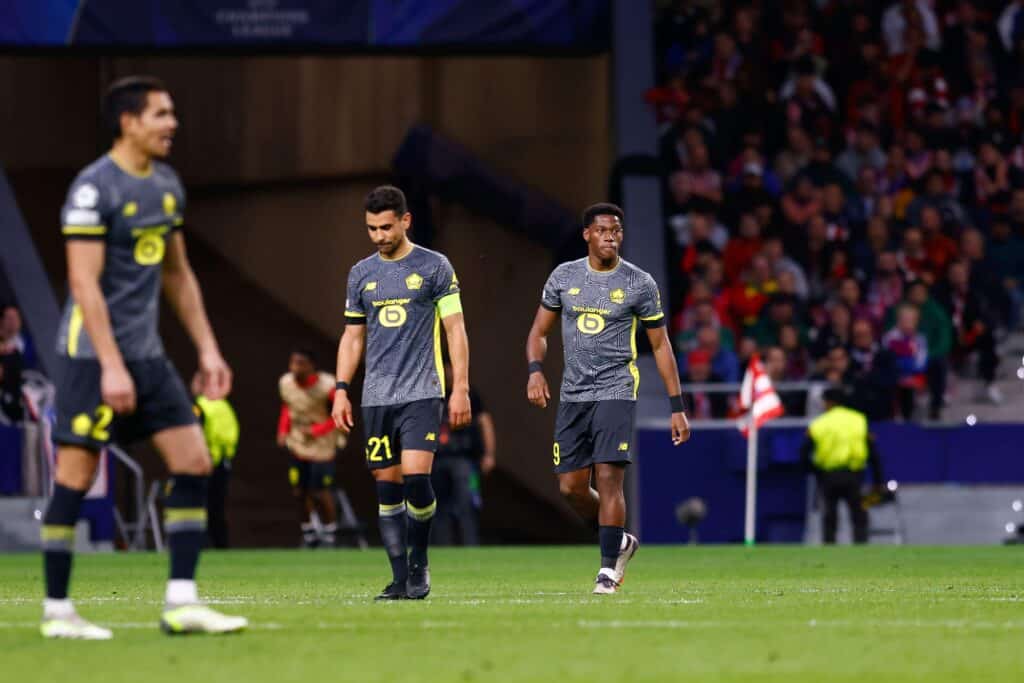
[362,398,444,470]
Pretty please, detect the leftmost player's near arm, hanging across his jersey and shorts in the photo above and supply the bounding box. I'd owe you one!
[66,240,135,414]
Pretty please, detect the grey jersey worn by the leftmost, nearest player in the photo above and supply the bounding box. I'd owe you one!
[57,156,185,360]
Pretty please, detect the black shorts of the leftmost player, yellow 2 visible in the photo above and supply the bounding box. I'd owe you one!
[53,356,197,453]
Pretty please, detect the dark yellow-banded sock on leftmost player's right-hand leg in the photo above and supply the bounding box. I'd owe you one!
[164,474,209,581]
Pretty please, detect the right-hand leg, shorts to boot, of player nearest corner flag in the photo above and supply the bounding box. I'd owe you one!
[591,400,640,593]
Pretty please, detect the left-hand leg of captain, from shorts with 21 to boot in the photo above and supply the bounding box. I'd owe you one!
[362,405,409,600]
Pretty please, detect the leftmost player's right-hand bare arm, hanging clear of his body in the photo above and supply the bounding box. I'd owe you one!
[162,231,231,400]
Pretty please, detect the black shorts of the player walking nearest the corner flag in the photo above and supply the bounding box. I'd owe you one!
[551,400,637,474]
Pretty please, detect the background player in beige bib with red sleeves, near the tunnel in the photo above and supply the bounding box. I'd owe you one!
[278,349,345,548]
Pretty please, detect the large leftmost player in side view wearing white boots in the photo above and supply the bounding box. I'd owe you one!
[40,77,247,640]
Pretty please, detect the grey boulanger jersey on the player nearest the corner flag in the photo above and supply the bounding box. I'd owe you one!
[541,258,665,402]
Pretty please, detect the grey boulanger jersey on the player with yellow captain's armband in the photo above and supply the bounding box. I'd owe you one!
[345,245,461,405]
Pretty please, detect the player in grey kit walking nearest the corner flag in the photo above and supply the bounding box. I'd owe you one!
[526,204,690,594]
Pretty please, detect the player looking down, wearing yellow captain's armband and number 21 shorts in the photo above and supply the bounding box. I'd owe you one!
[332,185,471,600]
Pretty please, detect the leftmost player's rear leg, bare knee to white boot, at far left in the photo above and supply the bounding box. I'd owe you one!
[40,445,113,640]
